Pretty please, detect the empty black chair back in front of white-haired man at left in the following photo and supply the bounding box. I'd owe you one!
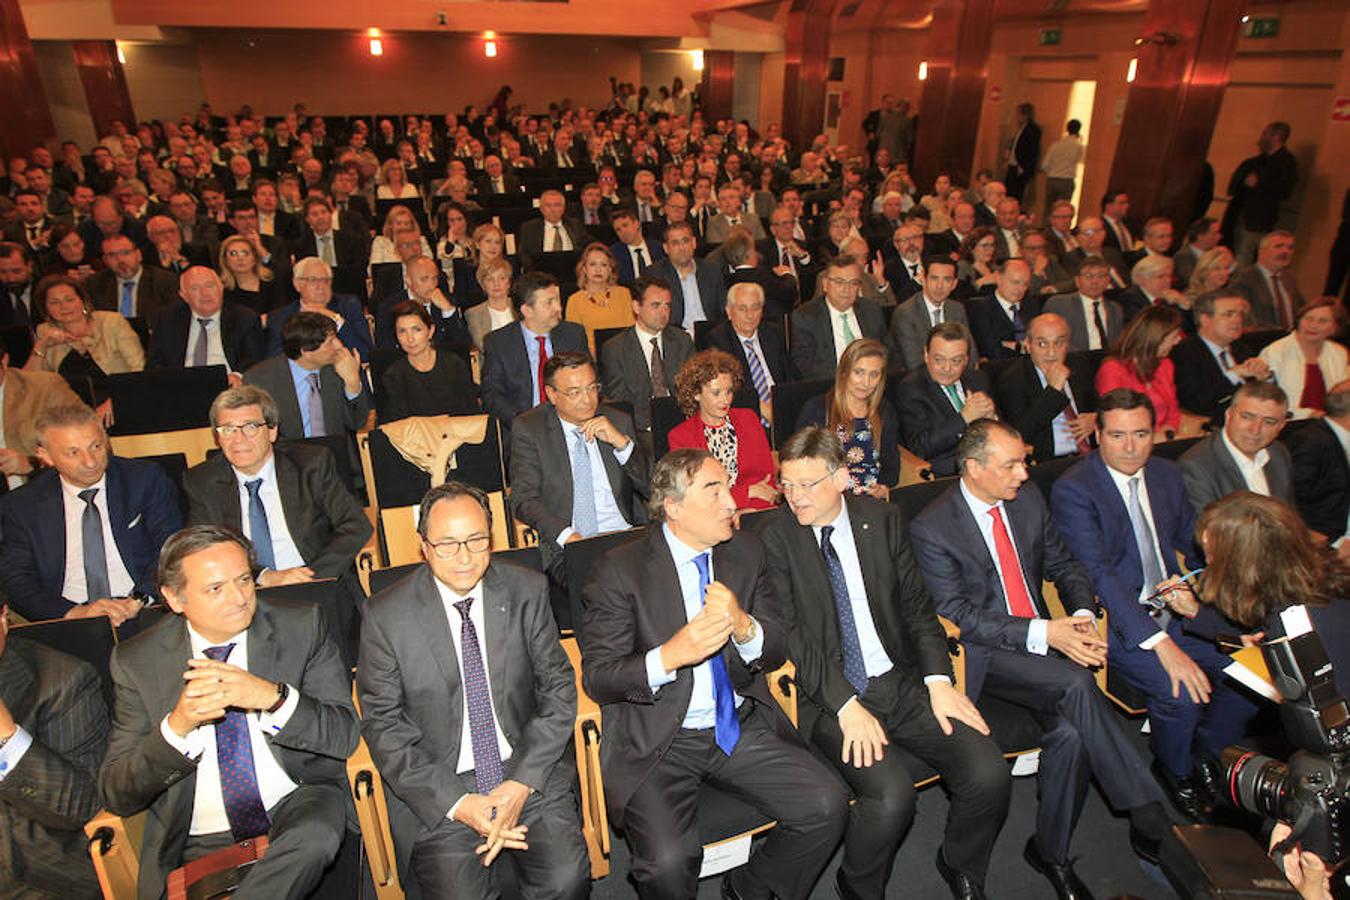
[108,366,230,436]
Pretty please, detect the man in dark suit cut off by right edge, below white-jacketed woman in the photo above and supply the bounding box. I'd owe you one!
[1284,381,1350,542]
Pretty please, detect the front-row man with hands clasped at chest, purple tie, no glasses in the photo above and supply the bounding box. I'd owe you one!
[99,525,360,900]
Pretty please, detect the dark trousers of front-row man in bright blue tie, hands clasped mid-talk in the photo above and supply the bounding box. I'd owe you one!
[624,699,848,900]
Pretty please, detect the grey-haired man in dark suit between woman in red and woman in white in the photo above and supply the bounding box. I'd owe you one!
[1172,291,1270,426]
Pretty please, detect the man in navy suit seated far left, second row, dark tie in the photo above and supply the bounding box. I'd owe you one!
[0,405,182,634]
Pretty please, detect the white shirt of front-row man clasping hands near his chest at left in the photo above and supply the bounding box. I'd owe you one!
[159,625,300,835]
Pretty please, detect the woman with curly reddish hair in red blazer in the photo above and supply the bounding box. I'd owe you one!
[670,349,782,509]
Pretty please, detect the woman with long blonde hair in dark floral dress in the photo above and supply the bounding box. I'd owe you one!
[797,337,900,501]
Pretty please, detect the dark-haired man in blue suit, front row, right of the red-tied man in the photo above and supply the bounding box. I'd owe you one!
[1052,389,1256,818]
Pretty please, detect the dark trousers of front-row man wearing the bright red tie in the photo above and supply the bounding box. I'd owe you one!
[984,650,1162,862]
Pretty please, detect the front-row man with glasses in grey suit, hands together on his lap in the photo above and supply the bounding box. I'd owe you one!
[356,485,590,900]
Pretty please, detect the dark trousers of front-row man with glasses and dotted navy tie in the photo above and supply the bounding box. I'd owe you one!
[811,671,1013,897]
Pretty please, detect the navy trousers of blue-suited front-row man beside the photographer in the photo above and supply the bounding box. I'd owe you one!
[1111,633,1258,777]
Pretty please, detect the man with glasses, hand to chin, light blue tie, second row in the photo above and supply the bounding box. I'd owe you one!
[510,351,651,584]
